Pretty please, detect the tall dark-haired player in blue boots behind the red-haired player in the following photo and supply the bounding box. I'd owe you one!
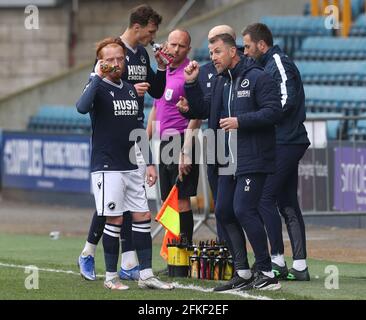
[78,5,166,280]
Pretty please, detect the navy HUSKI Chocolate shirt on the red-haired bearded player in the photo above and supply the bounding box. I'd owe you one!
[76,75,142,172]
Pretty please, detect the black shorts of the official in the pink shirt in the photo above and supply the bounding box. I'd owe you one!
[159,135,199,201]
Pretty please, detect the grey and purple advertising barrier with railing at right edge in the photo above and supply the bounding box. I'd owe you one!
[298,115,366,215]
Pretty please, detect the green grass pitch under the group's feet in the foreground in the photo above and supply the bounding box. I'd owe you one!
[0,234,366,300]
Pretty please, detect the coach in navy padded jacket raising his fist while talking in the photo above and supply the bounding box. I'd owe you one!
[179,34,281,291]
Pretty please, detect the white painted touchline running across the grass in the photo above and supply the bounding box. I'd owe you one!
[0,262,273,300]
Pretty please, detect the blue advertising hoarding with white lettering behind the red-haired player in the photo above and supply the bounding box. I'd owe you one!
[1,131,90,193]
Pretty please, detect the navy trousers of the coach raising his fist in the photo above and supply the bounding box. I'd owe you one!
[215,173,272,271]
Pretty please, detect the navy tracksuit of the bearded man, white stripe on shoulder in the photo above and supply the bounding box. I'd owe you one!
[257,46,310,260]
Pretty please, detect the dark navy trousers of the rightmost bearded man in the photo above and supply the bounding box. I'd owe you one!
[259,144,308,260]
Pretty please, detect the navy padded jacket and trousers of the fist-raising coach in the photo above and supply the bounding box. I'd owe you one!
[185,58,281,271]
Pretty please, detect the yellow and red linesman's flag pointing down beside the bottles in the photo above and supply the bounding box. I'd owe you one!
[155,185,180,260]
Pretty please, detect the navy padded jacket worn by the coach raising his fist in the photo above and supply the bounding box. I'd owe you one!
[183,49,281,175]
